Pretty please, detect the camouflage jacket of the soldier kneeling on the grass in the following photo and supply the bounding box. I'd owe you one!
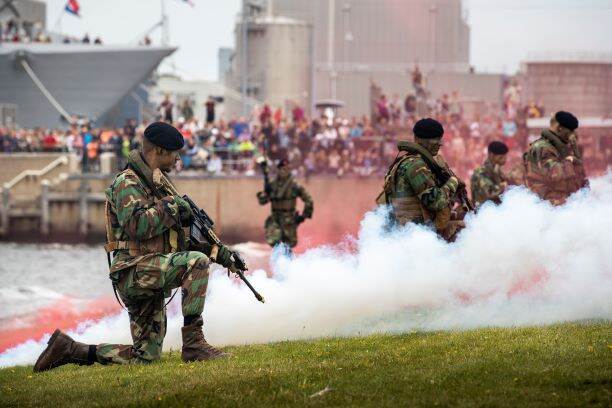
[105,151,188,273]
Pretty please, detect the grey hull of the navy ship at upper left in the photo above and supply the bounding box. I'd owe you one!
[0,43,175,128]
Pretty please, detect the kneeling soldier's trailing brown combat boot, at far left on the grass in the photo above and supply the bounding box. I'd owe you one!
[34,329,95,372]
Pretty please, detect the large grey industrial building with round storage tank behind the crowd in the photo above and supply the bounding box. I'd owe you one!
[225,0,502,115]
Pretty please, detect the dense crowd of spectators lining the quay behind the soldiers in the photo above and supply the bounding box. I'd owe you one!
[0,81,612,179]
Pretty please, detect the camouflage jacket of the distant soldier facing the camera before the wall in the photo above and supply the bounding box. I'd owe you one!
[257,176,314,218]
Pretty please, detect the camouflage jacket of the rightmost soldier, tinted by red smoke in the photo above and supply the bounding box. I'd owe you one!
[524,130,586,203]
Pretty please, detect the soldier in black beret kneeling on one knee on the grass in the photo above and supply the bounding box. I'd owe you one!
[34,122,239,371]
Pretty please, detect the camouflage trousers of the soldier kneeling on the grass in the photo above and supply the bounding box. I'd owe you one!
[96,251,210,364]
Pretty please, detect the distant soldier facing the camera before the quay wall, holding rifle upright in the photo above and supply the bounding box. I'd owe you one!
[257,160,314,248]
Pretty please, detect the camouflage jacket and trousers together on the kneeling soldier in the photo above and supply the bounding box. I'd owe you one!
[101,151,209,364]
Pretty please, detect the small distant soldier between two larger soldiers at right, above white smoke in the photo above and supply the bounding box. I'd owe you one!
[471,141,508,207]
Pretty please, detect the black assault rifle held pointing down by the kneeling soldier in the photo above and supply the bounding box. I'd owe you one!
[183,195,265,303]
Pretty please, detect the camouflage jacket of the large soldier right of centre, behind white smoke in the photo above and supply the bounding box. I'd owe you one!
[386,149,457,224]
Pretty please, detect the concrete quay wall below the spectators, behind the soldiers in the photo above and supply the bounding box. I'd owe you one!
[0,154,381,246]
